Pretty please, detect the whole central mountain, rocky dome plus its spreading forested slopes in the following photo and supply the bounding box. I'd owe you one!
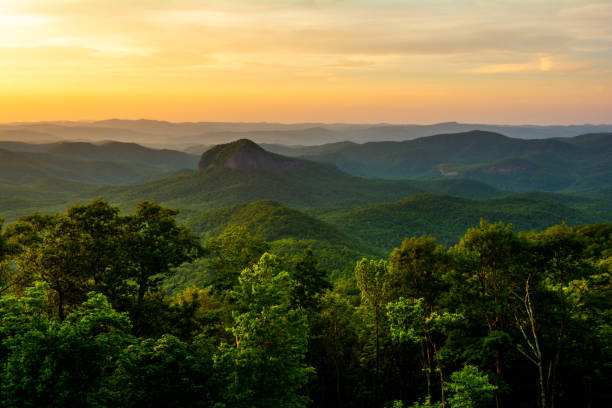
[102,141,502,211]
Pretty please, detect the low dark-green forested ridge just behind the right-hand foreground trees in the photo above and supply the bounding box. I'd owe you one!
[310,193,612,251]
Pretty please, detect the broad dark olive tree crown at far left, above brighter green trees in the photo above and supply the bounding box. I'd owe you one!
[6,199,130,319]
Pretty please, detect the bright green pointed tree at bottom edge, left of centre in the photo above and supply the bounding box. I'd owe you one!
[215,253,313,408]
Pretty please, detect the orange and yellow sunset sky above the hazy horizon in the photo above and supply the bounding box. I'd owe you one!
[0,0,612,124]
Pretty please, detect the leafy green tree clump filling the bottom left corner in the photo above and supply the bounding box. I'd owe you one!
[0,284,133,407]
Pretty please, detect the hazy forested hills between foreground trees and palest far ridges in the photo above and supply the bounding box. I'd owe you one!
[0,129,612,256]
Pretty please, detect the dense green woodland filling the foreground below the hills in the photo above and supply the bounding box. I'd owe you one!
[0,200,612,408]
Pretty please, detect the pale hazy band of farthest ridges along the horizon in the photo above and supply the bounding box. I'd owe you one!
[0,119,612,148]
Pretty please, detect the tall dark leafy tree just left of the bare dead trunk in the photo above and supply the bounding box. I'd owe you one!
[449,220,533,405]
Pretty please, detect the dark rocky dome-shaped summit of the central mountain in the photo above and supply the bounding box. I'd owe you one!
[198,139,311,173]
